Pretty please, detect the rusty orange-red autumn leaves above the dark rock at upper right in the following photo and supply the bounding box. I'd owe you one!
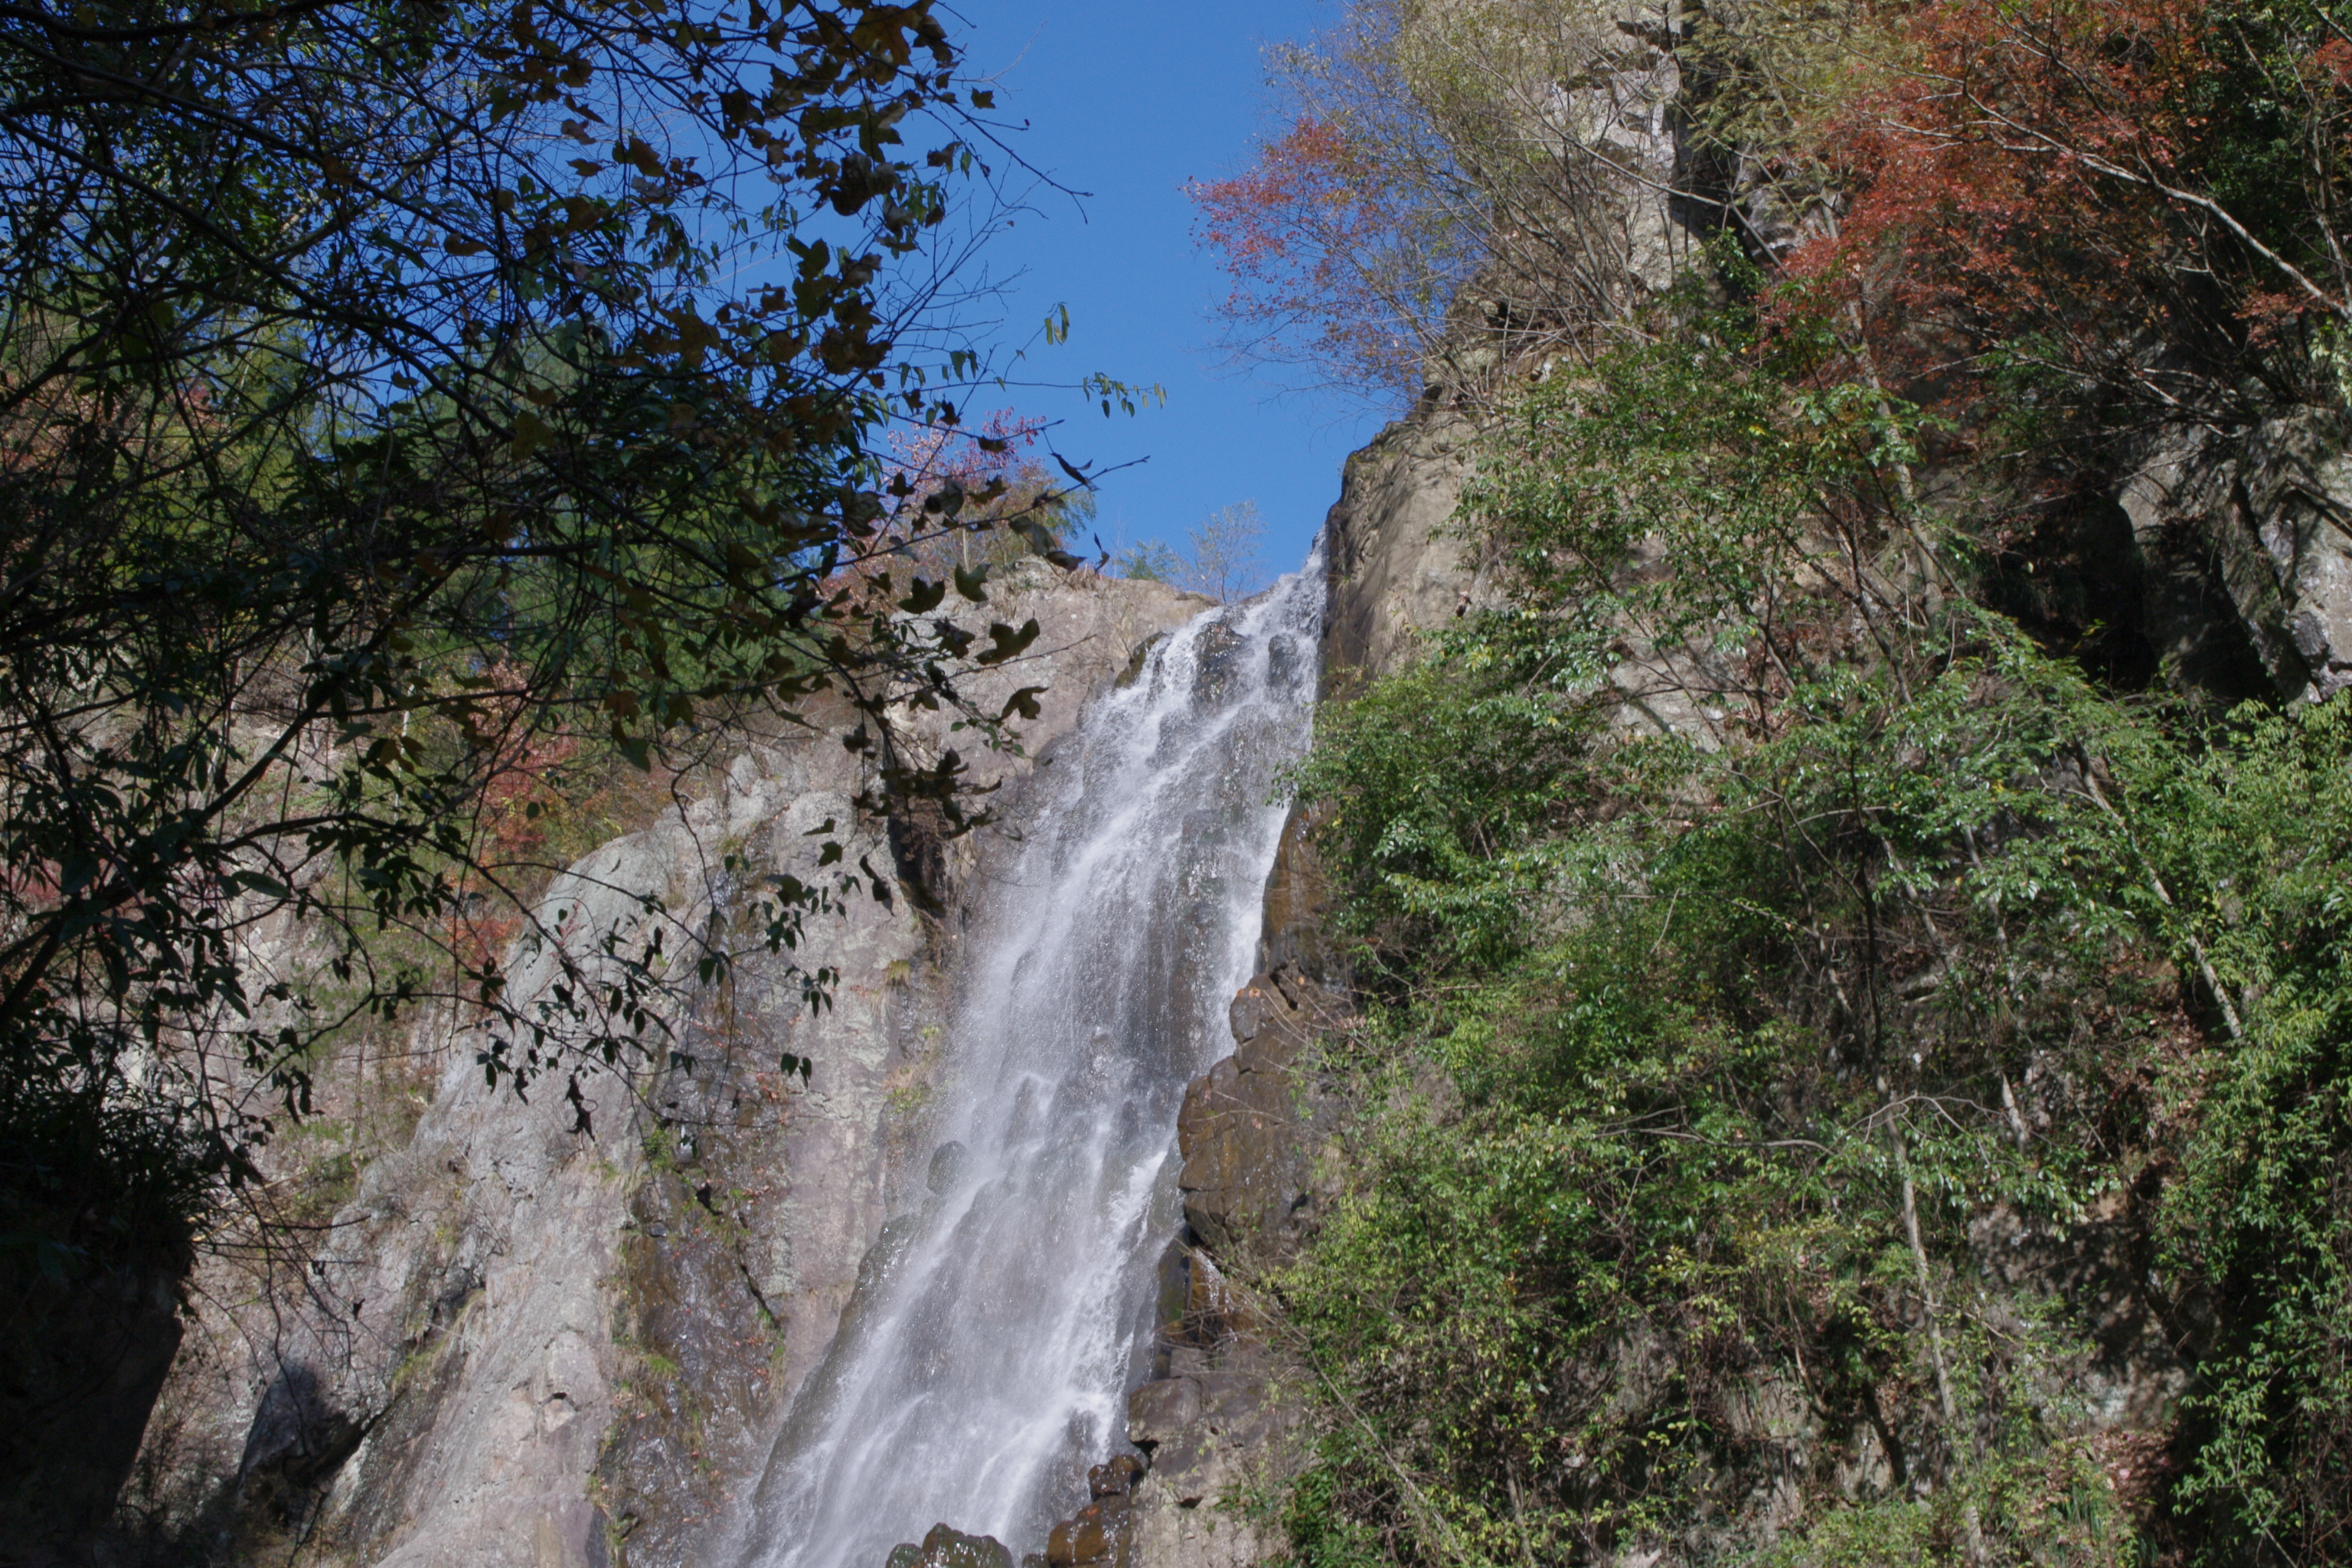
[1792,0,2314,416]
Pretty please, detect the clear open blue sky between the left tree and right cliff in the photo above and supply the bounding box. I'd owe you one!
[926,0,1380,587]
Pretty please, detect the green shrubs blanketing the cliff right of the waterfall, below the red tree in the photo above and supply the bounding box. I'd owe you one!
[1266,301,2352,1563]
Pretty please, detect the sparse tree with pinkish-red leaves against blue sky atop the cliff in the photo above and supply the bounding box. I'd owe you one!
[1190,0,1687,407]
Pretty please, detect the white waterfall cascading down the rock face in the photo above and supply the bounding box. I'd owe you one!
[743,550,1325,1568]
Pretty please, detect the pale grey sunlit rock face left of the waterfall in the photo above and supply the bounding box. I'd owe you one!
[110,564,1202,1568]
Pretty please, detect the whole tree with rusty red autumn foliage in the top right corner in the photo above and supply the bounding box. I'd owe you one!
[1792,0,2352,442]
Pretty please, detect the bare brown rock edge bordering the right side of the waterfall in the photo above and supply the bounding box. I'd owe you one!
[1096,407,1487,1568]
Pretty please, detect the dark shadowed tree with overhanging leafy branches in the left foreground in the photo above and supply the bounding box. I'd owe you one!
[0,0,1051,1279]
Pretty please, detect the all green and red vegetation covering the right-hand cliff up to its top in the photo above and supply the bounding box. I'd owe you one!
[1211,0,2352,1568]
